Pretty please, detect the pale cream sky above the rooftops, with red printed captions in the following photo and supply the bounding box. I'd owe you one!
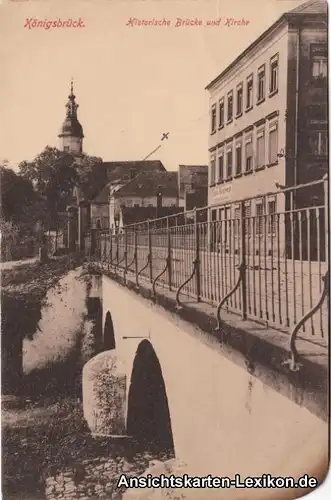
[0,0,303,170]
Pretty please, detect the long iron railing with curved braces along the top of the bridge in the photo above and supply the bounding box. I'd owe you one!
[86,177,329,362]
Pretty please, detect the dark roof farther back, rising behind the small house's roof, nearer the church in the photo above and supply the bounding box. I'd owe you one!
[103,160,166,182]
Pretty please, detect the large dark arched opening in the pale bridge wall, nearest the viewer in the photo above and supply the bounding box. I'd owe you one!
[127,340,174,453]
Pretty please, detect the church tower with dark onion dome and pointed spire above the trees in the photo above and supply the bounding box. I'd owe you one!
[58,80,84,154]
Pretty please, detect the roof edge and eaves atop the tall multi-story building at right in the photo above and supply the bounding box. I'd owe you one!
[205,0,328,90]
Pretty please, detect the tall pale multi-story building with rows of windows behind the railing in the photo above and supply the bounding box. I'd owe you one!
[206,0,328,256]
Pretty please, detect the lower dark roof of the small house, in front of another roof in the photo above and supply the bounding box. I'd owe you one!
[114,172,178,198]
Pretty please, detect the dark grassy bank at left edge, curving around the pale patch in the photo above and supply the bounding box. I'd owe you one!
[1,256,96,498]
